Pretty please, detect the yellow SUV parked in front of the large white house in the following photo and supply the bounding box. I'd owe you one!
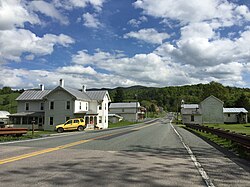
[55,118,86,133]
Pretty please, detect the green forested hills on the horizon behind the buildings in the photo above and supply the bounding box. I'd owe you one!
[0,82,250,113]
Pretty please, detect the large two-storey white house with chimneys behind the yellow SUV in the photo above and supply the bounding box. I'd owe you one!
[10,79,110,130]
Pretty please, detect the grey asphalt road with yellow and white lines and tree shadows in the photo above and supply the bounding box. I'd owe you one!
[0,117,250,187]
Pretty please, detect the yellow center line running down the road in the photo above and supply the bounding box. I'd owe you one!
[0,123,156,165]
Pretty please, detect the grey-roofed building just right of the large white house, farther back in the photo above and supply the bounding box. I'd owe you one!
[109,102,145,122]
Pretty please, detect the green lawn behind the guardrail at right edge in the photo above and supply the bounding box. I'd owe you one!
[205,123,250,135]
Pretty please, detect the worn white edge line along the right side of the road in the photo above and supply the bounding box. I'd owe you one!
[170,120,215,187]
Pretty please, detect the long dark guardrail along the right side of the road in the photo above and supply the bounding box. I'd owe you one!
[186,124,250,152]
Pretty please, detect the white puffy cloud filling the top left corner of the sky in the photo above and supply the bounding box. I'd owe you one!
[0,0,40,30]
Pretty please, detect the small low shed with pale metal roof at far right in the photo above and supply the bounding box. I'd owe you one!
[223,108,248,123]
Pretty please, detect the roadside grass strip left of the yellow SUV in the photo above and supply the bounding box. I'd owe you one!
[0,131,55,142]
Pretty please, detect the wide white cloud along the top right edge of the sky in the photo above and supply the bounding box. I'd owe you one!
[134,0,249,26]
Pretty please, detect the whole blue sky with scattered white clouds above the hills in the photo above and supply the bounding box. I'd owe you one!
[0,0,250,89]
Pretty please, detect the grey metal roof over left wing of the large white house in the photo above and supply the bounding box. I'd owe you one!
[16,90,51,101]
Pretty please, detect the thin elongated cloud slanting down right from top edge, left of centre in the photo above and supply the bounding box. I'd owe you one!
[29,1,69,25]
